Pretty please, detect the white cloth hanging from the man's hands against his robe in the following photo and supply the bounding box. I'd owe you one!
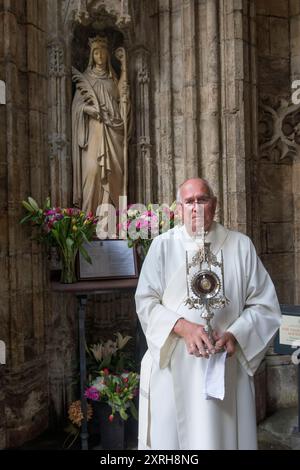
[204,351,227,400]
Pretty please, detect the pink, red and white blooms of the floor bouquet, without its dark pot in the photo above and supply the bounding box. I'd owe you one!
[85,333,139,421]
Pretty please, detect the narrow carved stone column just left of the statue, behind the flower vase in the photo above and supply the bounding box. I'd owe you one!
[46,0,78,428]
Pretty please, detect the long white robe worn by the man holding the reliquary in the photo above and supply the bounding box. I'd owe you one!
[136,222,281,450]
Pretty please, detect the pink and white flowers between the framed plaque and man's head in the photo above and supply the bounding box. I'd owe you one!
[118,202,176,258]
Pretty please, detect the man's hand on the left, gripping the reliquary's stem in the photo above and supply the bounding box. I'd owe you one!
[173,318,215,358]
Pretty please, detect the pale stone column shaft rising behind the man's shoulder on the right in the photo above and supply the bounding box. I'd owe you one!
[220,0,249,232]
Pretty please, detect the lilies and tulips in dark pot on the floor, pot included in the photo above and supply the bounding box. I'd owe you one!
[85,333,139,449]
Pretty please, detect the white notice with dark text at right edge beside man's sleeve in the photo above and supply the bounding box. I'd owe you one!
[274,305,300,354]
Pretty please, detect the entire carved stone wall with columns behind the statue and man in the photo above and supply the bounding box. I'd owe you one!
[0,0,300,447]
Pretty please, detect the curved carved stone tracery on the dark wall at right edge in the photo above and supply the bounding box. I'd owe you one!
[258,97,300,163]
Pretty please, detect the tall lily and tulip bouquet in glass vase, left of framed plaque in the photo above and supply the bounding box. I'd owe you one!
[21,197,97,283]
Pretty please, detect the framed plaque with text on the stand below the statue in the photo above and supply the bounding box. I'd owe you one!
[77,238,138,281]
